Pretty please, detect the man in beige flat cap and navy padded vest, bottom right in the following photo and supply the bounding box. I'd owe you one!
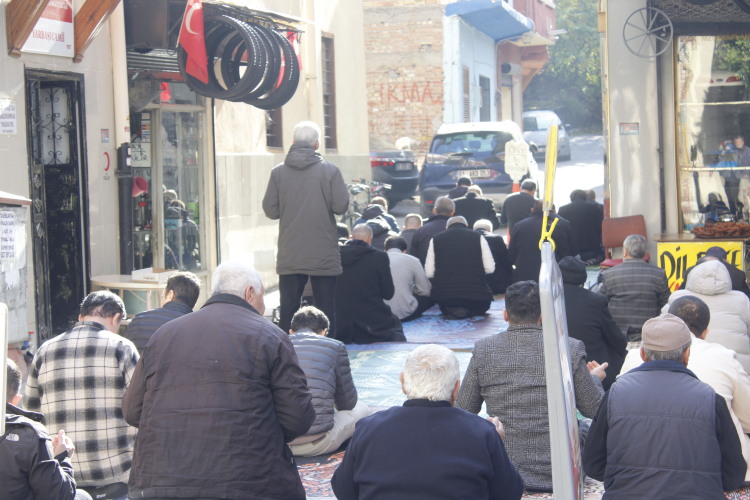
[583,313,746,500]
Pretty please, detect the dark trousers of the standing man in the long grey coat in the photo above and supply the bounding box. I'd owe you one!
[279,274,336,338]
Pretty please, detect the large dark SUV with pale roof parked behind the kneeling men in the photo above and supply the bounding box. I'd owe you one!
[419,121,542,217]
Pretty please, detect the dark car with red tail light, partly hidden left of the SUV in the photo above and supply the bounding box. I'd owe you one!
[370,137,419,207]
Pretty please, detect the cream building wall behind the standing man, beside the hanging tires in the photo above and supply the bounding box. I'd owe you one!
[215,0,371,289]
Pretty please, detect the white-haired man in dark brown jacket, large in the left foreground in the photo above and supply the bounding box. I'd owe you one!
[122,260,315,500]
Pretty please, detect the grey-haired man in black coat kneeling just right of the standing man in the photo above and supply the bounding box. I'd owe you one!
[336,224,406,344]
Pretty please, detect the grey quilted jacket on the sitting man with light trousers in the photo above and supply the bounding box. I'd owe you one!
[289,328,357,435]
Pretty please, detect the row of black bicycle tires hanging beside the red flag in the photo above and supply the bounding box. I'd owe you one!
[177,15,299,110]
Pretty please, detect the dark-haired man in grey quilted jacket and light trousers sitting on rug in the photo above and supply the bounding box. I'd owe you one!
[289,307,370,457]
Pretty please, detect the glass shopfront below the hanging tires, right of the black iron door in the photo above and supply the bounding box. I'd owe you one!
[130,83,206,271]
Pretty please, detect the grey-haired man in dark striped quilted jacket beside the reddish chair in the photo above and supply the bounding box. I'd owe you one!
[593,234,672,341]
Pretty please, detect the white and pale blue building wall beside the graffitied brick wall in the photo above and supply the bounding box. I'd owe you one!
[443,16,497,123]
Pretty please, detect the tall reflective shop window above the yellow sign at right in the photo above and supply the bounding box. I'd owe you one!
[676,35,750,231]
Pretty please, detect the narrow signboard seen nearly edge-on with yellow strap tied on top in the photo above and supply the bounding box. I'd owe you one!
[539,125,583,500]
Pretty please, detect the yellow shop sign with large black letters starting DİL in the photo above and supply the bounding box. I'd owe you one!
[656,240,745,292]
